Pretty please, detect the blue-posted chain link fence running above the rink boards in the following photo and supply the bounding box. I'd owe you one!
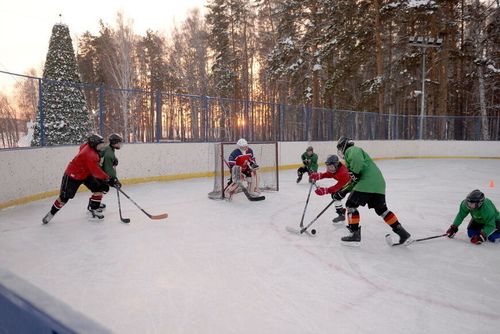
[0,71,500,148]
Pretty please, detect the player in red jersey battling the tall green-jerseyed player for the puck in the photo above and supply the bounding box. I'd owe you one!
[309,154,351,223]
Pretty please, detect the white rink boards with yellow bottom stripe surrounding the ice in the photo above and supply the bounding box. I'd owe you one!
[0,140,500,204]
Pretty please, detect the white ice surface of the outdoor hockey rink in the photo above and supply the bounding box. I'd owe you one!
[0,159,500,334]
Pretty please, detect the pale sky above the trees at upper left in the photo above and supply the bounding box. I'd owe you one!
[0,0,208,91]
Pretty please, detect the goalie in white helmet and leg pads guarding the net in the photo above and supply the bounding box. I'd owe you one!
[224,138,265,201]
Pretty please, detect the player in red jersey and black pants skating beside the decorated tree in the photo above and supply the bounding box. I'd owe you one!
[42,134,115,224]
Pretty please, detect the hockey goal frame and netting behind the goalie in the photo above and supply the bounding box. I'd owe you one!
[208,142,279,199]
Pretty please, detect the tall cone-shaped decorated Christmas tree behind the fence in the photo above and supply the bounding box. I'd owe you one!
[31,23,92,146]
